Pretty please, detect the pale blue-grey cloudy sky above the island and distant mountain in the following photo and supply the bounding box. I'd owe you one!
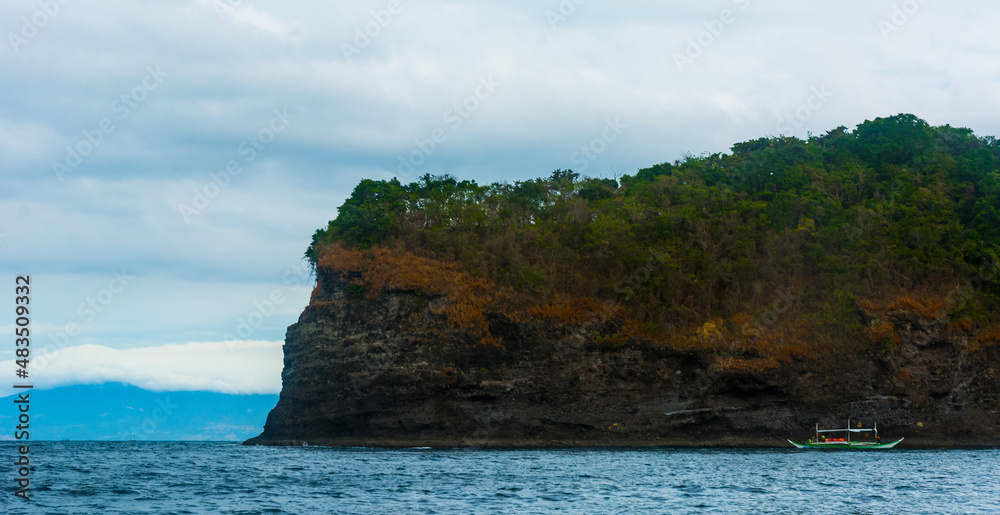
[0,0,1000,395]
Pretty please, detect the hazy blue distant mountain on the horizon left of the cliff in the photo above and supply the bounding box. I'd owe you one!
[0,384,278,441]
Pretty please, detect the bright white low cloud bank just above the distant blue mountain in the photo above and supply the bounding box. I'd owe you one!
[0,341,283,396]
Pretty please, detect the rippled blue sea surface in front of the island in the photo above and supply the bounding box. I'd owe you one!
[0,442,1000,514]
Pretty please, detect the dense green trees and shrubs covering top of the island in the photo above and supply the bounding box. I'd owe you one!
[306,115,1000,354]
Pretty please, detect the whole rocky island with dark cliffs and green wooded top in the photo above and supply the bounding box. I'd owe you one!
[247,115,1000,447]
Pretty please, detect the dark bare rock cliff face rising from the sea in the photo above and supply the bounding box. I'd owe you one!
[247,260,1000,446]
